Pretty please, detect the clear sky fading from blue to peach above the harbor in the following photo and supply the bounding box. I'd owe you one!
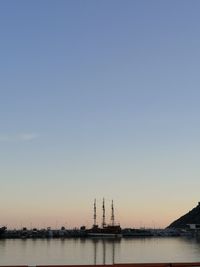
[0,0,200,228]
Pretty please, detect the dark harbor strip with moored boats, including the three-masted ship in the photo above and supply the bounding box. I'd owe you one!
[0,199,188,239]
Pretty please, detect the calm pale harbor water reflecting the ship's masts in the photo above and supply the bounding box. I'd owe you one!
[0,237,200,265]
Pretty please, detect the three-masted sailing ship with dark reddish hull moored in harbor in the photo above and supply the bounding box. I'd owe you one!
[86,199,122,238]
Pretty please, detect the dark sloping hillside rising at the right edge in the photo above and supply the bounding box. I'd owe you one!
[167,202,200,228]
